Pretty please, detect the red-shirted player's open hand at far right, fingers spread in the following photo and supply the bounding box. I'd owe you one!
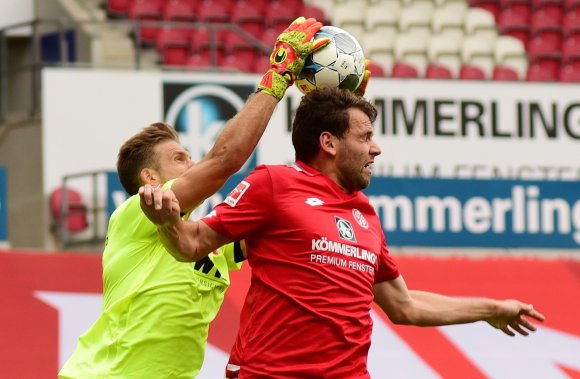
[486,300,545,337]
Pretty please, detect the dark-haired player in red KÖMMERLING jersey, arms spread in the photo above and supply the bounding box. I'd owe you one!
[141,89,544,379]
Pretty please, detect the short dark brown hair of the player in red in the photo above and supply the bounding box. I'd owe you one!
[292,88,377,162]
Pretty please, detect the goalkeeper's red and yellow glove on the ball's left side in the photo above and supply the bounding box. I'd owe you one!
[258,17,330,101]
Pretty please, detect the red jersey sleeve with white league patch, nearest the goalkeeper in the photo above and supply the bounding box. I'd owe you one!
[202,166,275,241]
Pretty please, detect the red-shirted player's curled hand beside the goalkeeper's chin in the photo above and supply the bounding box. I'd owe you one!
[139,184,181,226]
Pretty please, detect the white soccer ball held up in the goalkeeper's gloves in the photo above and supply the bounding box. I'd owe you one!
[296,26,365,94]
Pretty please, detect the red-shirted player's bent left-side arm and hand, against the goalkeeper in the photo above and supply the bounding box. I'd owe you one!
[139,184,231,262]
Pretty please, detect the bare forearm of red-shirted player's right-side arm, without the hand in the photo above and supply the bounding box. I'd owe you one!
[409,291,498,326]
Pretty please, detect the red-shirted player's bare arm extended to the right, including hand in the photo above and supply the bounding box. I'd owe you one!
[374,276,544,336]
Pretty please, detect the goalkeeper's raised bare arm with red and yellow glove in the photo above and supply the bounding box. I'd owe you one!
[171,17,328,212]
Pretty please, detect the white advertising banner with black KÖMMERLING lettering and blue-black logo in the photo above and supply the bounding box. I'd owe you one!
[43,69,580,200]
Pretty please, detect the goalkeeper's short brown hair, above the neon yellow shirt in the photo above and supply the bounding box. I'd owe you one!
[117,122,179,195]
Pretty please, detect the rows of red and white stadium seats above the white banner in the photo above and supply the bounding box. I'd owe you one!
[90,0,580,82]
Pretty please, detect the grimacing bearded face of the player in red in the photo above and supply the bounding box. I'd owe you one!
[336,109,381,192]
